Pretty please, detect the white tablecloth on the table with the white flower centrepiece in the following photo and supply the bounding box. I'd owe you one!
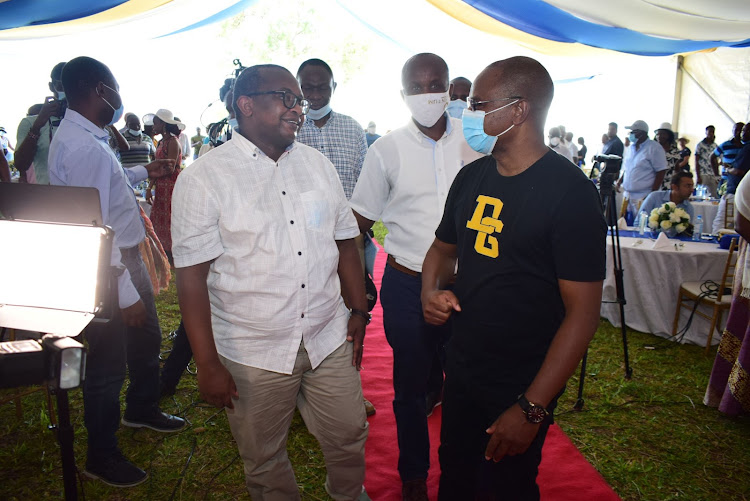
[601,236,727,346]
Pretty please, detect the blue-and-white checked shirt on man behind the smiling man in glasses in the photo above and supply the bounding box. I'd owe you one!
[297,111,367,200]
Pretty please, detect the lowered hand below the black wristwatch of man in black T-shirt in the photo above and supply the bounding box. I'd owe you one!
[484,404,541,462]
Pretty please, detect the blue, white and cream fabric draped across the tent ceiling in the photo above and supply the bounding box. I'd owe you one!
[0,0,750,56]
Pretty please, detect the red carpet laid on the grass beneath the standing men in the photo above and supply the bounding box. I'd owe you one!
[361,244,620,501]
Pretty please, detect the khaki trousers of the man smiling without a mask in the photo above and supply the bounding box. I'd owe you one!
[220,341,368,501]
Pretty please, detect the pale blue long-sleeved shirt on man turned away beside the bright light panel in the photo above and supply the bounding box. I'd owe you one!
[49,108,148,308]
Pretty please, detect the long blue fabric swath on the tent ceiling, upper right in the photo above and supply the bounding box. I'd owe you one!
[463,0,750,56]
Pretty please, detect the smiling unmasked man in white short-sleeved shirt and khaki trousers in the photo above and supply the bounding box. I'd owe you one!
[172,65,369,500]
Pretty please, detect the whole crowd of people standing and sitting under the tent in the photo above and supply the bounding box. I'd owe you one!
[0,47,750,500]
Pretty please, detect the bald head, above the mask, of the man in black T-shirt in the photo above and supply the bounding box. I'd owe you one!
[475,56,555,127]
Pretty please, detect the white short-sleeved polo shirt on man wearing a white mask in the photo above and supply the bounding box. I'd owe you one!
[350,117,482,272]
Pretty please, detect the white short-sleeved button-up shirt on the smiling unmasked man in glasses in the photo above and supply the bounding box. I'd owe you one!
[172,132,359,374]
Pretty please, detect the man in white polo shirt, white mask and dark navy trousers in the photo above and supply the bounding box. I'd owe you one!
[350,50,481,499]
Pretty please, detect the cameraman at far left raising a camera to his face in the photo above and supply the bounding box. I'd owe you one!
[15,62,68,184]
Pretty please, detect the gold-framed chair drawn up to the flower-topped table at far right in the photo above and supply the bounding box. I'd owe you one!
[672,238,737,355]
